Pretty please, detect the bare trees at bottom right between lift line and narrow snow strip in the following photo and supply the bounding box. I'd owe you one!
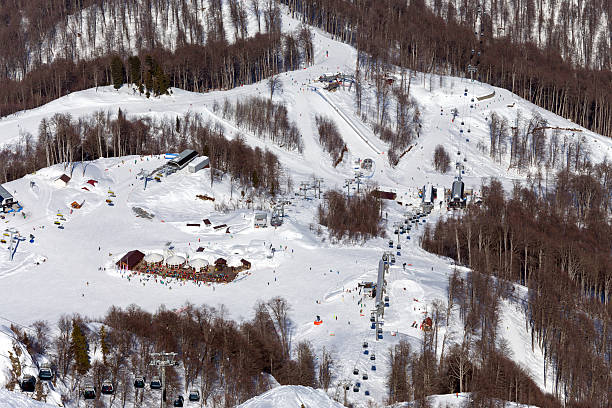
[387,264,564,408]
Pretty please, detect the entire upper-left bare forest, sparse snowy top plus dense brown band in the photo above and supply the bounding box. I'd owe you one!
[0,0,314,116]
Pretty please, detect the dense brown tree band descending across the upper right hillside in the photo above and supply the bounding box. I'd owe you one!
[282,0,612,136]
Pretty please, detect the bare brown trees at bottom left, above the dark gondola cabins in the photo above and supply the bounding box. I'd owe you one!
[11,297,326,407]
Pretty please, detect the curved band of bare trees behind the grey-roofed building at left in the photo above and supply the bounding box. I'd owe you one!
[0,110,284,195]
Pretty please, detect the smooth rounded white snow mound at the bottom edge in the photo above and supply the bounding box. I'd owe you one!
[238,385,342,408]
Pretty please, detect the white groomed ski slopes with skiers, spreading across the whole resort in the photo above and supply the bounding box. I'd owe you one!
[0,3,612,408]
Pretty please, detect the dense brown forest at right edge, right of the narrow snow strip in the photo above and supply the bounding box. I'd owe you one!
[423,174,612,407]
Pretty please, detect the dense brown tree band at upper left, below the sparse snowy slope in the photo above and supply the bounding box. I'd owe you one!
[0,2,314,116]
